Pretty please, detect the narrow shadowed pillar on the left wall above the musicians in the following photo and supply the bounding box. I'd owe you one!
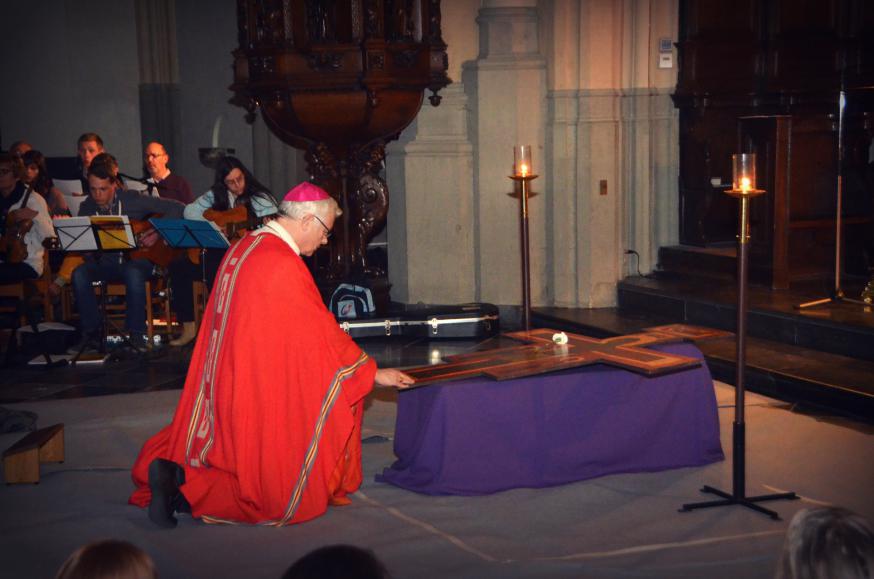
[135,0,182,161]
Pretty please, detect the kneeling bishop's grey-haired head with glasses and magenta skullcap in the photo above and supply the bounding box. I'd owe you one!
[279,182,343,255]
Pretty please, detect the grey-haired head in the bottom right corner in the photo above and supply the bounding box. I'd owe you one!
[777,507,874,579]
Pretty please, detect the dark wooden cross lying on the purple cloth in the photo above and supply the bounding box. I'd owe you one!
[404,326,725,388]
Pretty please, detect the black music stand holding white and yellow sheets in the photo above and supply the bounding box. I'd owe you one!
[52,215,142,365]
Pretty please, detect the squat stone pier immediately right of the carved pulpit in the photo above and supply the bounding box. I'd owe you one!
[386,83,476,304]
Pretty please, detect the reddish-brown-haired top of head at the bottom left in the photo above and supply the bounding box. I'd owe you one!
[55,539,158,579]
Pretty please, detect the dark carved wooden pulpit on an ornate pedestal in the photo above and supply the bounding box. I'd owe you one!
[231,0,449,297]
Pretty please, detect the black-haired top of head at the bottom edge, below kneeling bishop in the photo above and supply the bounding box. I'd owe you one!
[282,545,391,579]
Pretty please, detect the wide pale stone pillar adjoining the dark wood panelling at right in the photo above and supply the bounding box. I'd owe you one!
[544,0,678,307]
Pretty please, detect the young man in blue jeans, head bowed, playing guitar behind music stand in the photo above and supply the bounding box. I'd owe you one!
[71,153,184,351]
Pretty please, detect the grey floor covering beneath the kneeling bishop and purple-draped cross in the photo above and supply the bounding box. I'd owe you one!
[0,374,874,579]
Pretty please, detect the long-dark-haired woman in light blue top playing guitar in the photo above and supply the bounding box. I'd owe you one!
[168,157,277,346]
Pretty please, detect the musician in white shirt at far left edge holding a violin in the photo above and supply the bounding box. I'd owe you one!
[0,152,55,284]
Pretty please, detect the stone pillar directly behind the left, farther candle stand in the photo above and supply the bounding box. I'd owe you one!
[462,0,548,305]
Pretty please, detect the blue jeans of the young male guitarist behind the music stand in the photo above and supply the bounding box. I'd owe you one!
[72,254,154,334]
